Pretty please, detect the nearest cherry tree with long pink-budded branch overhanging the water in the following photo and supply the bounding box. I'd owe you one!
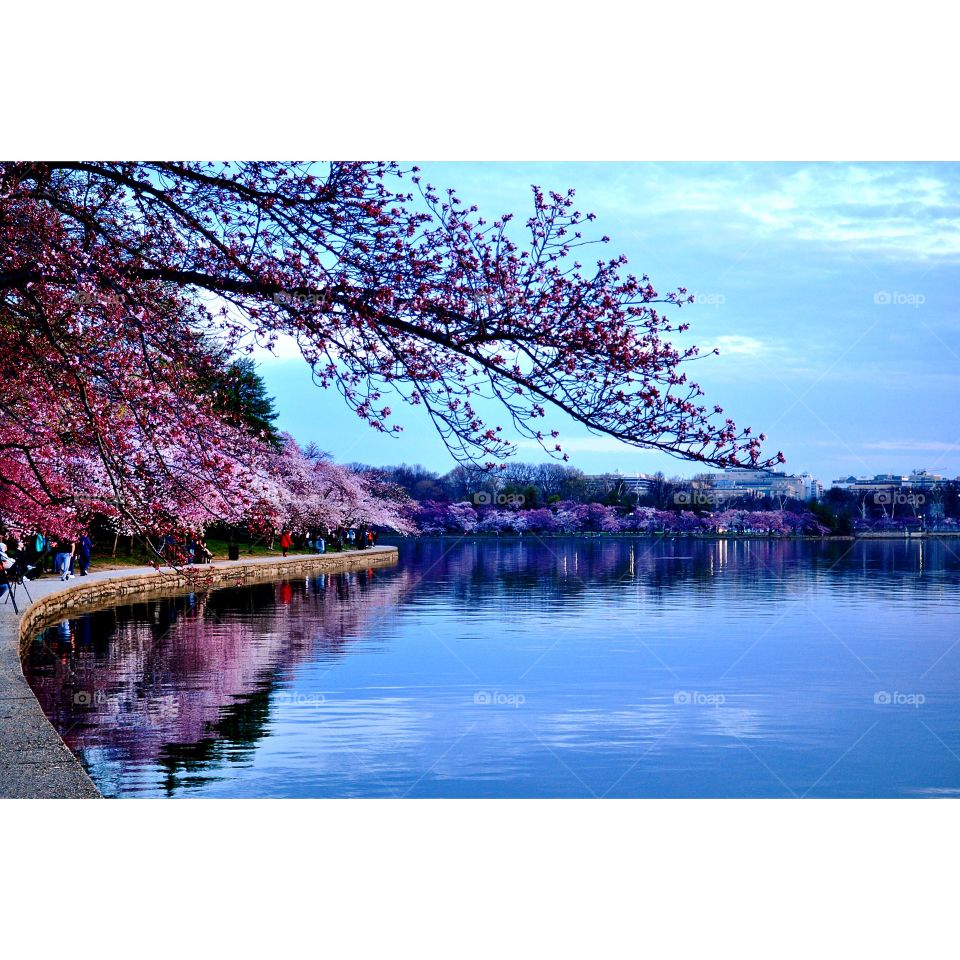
[0,161,782,540]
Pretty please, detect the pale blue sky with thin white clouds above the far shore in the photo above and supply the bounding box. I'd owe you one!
[260,163,960,482]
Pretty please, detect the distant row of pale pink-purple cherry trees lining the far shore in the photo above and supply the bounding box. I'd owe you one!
[417,501,829,537]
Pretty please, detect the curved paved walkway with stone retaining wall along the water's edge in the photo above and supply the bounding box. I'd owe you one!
[0,547,397,798]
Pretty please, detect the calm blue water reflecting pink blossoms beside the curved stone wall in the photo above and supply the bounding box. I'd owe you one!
[24,537,960,797]
